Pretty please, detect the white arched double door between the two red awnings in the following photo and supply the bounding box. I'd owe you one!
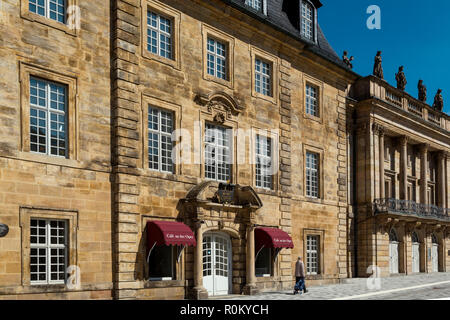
[203,233,232,296]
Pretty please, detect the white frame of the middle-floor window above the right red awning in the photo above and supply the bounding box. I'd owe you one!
[255,134,273,190]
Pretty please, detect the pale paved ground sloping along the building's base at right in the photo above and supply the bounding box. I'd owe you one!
[216,273,450,300]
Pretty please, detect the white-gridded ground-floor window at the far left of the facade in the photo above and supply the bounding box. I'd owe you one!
[30,219,68,284]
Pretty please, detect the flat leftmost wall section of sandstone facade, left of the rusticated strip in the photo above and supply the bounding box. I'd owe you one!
[0,0,113,299]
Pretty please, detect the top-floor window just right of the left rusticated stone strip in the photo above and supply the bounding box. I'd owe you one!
[147,11,173,59]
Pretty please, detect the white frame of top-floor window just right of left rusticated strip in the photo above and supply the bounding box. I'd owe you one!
[147,8,174,60]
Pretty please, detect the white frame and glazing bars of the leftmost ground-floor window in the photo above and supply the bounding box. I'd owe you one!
[30,218,69,285]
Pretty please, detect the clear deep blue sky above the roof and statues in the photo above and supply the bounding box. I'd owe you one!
[319,0,450,113]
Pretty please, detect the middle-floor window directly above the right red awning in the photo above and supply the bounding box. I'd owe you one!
[256,135,272,189]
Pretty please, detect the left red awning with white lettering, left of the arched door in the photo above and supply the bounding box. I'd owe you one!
[147,221,197,249]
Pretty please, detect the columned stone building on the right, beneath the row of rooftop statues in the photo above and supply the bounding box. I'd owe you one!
[349,76,450,276]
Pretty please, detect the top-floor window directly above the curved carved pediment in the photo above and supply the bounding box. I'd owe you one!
[207,38,227,80]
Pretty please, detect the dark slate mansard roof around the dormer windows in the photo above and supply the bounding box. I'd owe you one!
[222,0,350,70]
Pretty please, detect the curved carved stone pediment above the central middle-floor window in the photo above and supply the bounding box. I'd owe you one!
[195,92,245,123]
